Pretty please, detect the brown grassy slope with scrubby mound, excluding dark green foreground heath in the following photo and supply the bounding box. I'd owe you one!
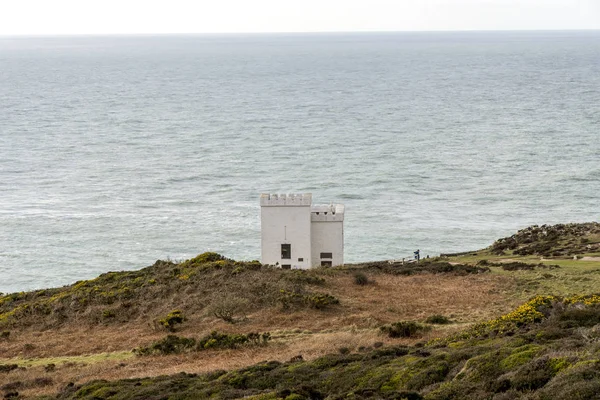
[0,253,510,397]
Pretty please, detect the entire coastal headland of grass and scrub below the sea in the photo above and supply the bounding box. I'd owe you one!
[0,223,600,399]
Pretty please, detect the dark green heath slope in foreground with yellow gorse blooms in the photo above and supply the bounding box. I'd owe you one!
[39,296,600,400]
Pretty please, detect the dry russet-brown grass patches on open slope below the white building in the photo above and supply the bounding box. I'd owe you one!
[0,273,518,396]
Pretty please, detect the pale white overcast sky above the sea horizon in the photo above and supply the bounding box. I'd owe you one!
[0,0,600,35]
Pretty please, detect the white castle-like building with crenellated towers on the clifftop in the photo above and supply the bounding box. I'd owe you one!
[260,193,344,269]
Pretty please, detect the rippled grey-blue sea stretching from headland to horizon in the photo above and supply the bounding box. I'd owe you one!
[0,31,600,292]
